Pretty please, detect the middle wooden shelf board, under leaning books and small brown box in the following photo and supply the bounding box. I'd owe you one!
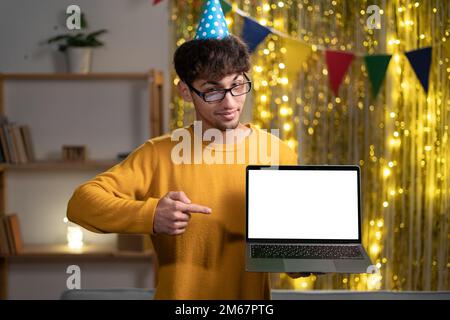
[0,159,120,171]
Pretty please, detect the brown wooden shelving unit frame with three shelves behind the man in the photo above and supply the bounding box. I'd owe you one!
[0,69,164,299]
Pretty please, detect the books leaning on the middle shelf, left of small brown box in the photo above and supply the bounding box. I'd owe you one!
[0,118,35,164]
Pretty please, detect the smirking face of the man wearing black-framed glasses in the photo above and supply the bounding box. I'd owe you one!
[182,73,247,131]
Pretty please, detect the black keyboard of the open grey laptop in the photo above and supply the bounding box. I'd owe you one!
[251,244,364,259]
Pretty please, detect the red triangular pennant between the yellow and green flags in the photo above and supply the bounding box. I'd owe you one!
[325,50,355,96]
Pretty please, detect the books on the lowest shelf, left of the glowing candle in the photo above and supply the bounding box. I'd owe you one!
[0,213,23,255]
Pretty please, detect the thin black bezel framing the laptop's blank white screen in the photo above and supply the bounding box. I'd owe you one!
[245,165,362,244]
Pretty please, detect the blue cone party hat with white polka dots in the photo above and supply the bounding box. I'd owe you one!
[194,0,230,40]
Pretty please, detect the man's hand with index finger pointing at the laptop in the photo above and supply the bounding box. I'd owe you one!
[153,191,211,235]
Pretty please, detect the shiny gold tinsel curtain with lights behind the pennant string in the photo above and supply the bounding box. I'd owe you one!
[171,0,450,290]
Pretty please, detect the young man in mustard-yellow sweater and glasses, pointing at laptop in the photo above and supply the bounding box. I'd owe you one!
[67,1,304,299]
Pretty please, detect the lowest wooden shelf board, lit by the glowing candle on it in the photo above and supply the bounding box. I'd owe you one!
[1,244,153,260]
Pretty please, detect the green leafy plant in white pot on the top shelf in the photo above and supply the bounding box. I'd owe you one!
[47,13,107,73]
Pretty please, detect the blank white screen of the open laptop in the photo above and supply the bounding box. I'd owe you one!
[248,169,358,240]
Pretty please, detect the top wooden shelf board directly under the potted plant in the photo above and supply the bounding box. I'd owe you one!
[1,72,149,80]
